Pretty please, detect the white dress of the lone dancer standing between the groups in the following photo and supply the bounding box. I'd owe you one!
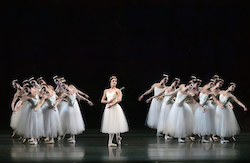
[101,91,129,134]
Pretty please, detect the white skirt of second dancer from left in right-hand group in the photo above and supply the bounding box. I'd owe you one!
[157,101,173,132]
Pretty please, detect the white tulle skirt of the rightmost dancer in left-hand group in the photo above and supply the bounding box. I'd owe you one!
[60,100,85,135]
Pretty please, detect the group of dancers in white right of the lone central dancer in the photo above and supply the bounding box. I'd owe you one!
[138,74,247,143]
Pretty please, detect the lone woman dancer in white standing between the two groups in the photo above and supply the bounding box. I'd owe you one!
[101,76,129,147]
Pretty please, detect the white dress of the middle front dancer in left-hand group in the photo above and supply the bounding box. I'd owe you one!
[43,94,62,138]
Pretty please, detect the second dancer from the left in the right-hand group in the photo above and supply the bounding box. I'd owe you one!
[146,78,180,139]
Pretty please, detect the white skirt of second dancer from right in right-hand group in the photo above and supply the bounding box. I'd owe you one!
[193,103,215,136]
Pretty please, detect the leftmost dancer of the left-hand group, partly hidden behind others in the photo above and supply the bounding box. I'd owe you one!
[10,80,25,137]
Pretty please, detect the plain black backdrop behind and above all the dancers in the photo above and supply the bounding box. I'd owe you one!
[0,0,250,132]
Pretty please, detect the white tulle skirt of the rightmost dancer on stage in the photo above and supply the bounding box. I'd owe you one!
[215,105,240,137]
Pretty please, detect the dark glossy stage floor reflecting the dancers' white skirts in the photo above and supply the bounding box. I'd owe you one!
[0,129,250,163]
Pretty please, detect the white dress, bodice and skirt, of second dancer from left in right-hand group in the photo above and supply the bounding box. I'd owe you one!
[157,91,175,134]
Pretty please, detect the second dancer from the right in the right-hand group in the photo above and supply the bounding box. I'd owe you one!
[193,80,223,143]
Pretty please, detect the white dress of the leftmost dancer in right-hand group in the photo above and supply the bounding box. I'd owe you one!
[146,87,164,129]
